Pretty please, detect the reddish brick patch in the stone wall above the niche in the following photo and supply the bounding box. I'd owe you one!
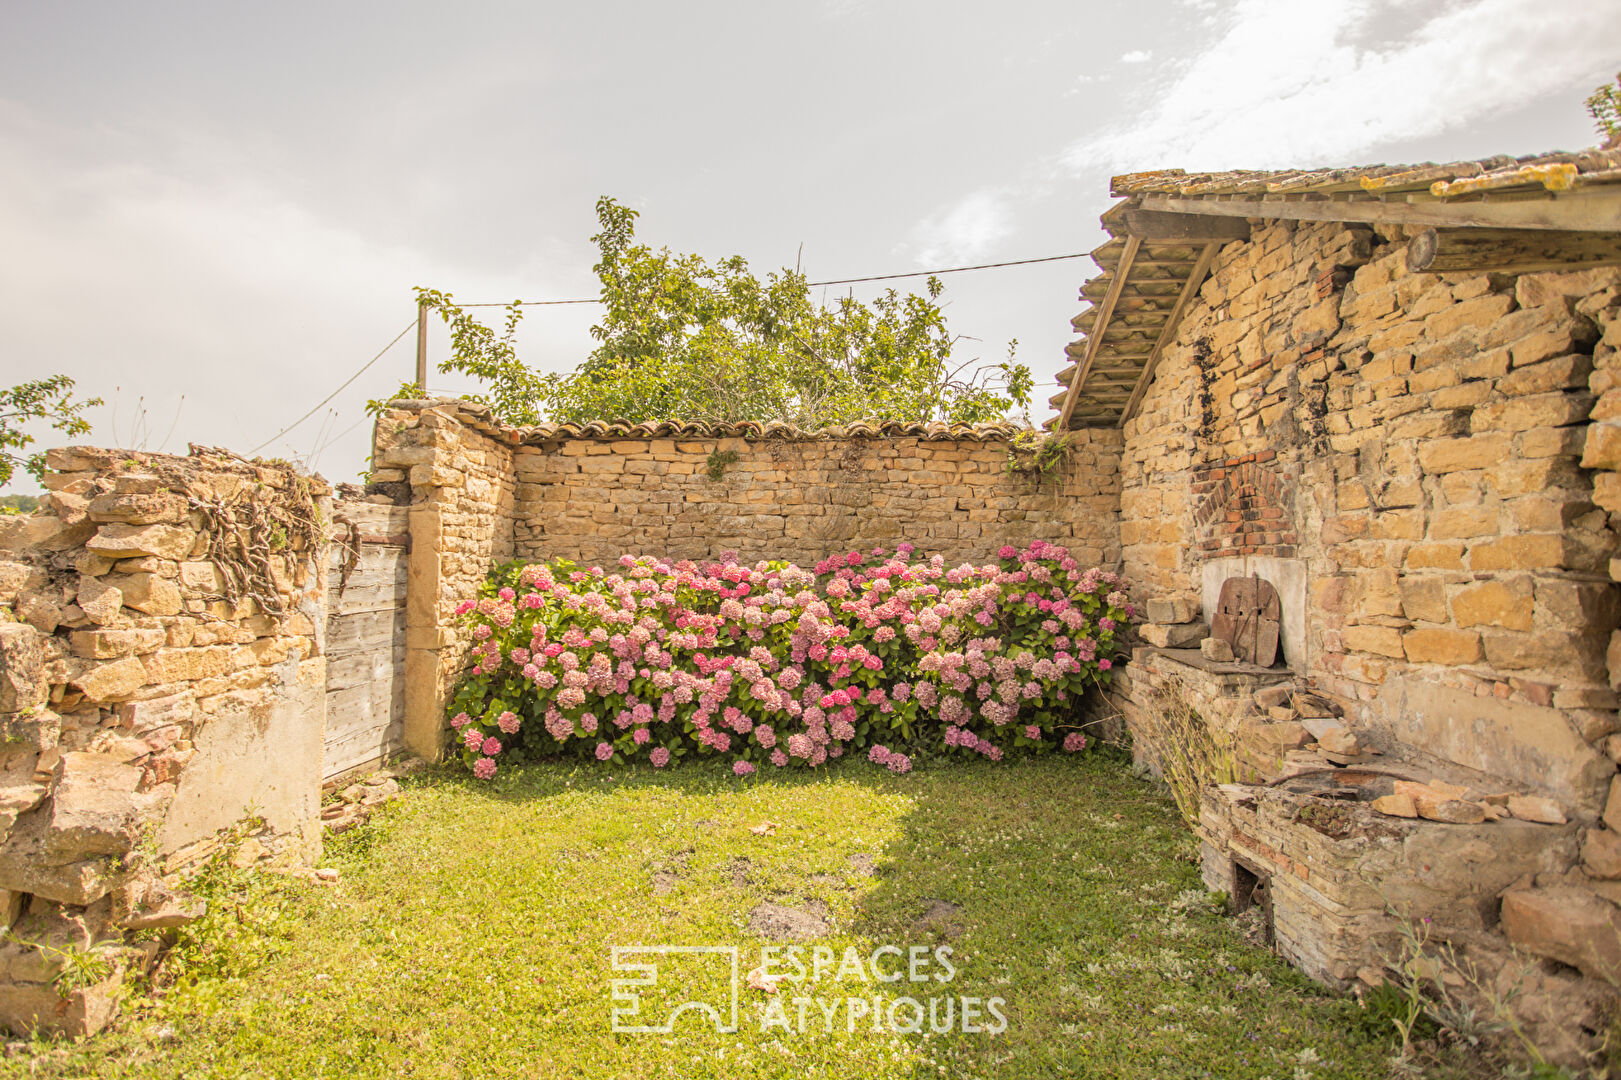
[1193,451,1300,558]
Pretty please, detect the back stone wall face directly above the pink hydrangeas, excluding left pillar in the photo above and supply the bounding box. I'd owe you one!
[515,431,1118,566]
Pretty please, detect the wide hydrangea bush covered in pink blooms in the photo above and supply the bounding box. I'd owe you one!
[451,540,1135,778]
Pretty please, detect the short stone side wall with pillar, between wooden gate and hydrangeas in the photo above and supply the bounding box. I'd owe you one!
[371,401,514,761]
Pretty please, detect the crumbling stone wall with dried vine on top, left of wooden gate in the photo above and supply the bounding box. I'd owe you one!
[0,448,327,1031]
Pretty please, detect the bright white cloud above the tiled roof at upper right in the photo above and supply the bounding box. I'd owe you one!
[1067,0,1621,170]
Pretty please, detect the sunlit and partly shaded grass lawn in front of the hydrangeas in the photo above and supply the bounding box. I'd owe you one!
[0,756,1392,1080]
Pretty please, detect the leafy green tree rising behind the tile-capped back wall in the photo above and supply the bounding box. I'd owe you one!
[417,196,1033,428]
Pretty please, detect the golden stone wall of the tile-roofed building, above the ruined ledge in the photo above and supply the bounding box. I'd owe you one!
[1122,224,1618,797]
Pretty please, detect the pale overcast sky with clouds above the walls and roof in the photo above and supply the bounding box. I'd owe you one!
[0,0,1621,490]
